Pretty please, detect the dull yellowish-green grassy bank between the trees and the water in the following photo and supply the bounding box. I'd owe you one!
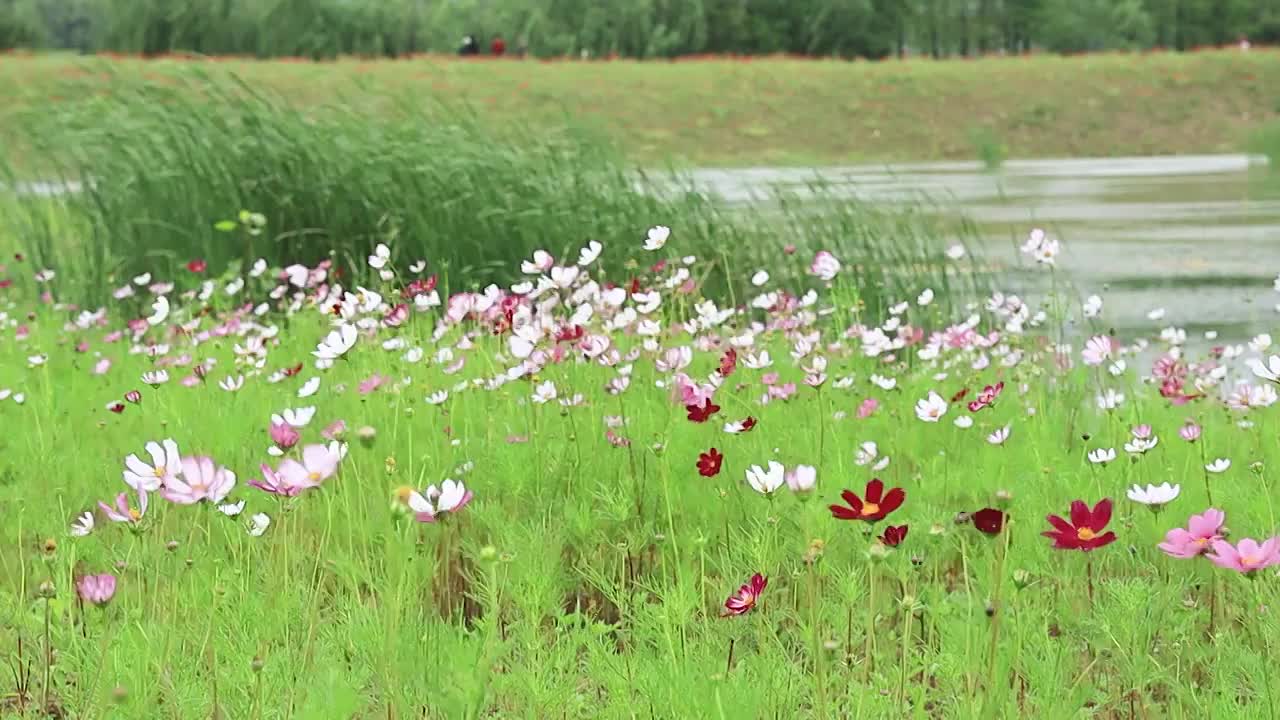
[0,50,1280,167]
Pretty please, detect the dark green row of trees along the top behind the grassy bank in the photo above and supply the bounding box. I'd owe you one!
[0,0,1280,59]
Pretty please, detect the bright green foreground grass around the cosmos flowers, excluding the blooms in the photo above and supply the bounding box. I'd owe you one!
[0,227,1280,719]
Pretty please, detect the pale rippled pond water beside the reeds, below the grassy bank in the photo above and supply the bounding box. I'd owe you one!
[694,155,1280,340]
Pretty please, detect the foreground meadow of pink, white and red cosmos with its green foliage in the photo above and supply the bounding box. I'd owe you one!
[0,211,1280,719]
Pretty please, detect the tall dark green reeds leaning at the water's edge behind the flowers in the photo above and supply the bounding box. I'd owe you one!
[0,63,972,304]
